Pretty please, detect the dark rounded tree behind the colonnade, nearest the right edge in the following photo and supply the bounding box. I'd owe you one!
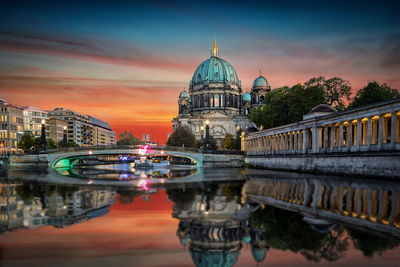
[348,81,400,109]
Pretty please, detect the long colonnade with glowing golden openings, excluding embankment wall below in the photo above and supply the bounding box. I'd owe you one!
[242,98,400,156]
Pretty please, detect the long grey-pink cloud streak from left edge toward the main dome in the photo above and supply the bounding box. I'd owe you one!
[0,32,198,70]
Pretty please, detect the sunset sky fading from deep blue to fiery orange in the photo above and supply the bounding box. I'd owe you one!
[0,0,400,144]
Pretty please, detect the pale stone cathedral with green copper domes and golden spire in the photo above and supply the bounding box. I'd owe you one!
[172,39,271,147]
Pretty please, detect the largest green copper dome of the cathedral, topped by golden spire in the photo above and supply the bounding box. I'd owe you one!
[191,40,240,86]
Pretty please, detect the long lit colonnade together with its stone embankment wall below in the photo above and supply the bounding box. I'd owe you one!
[242,98,400,178]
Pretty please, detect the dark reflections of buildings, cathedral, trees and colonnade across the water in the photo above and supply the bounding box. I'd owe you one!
[0,170,400,266]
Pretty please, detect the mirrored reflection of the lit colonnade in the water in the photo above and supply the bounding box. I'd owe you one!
[245,175,400,238]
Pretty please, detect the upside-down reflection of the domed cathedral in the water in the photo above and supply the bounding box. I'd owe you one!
[169,184,268,266]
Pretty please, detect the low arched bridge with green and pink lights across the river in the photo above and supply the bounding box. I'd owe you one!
[10,147,243,169]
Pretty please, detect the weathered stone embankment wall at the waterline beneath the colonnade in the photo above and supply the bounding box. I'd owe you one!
[245,152,400,178]
